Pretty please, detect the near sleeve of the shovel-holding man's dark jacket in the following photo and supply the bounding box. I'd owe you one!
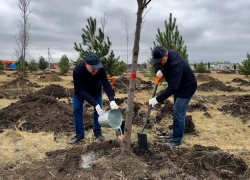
[156,64,183,102]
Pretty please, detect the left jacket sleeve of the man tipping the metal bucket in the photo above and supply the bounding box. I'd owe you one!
[73,71,98,107]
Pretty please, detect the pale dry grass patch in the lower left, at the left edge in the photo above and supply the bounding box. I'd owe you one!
[0,130,67,168]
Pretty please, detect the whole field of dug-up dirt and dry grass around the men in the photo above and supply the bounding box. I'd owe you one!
[0,70,250,179]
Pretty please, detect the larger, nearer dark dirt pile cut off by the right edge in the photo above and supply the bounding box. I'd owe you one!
[218,95,250,122]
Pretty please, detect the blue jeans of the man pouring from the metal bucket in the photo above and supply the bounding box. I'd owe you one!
[73,93,102,136]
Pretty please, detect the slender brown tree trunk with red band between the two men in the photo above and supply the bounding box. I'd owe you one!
[122,0,151,153]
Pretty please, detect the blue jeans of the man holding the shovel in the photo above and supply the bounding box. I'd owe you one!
[172,96,192,143]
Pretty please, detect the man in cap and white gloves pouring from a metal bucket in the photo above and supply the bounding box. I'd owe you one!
[70,54,118,144]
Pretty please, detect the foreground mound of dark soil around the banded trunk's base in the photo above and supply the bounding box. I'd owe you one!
[1,141,250,180]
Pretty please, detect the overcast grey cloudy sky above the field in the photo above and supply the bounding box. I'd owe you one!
[0,0,250,63]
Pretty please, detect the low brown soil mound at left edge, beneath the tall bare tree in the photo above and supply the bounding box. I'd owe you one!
[0,77,41,89]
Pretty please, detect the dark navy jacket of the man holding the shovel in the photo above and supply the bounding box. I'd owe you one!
[154,50,197,102]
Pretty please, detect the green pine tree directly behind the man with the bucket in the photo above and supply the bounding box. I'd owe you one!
[73,17,124,75]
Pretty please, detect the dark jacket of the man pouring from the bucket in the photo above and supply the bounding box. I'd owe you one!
[73,62,114,106]
